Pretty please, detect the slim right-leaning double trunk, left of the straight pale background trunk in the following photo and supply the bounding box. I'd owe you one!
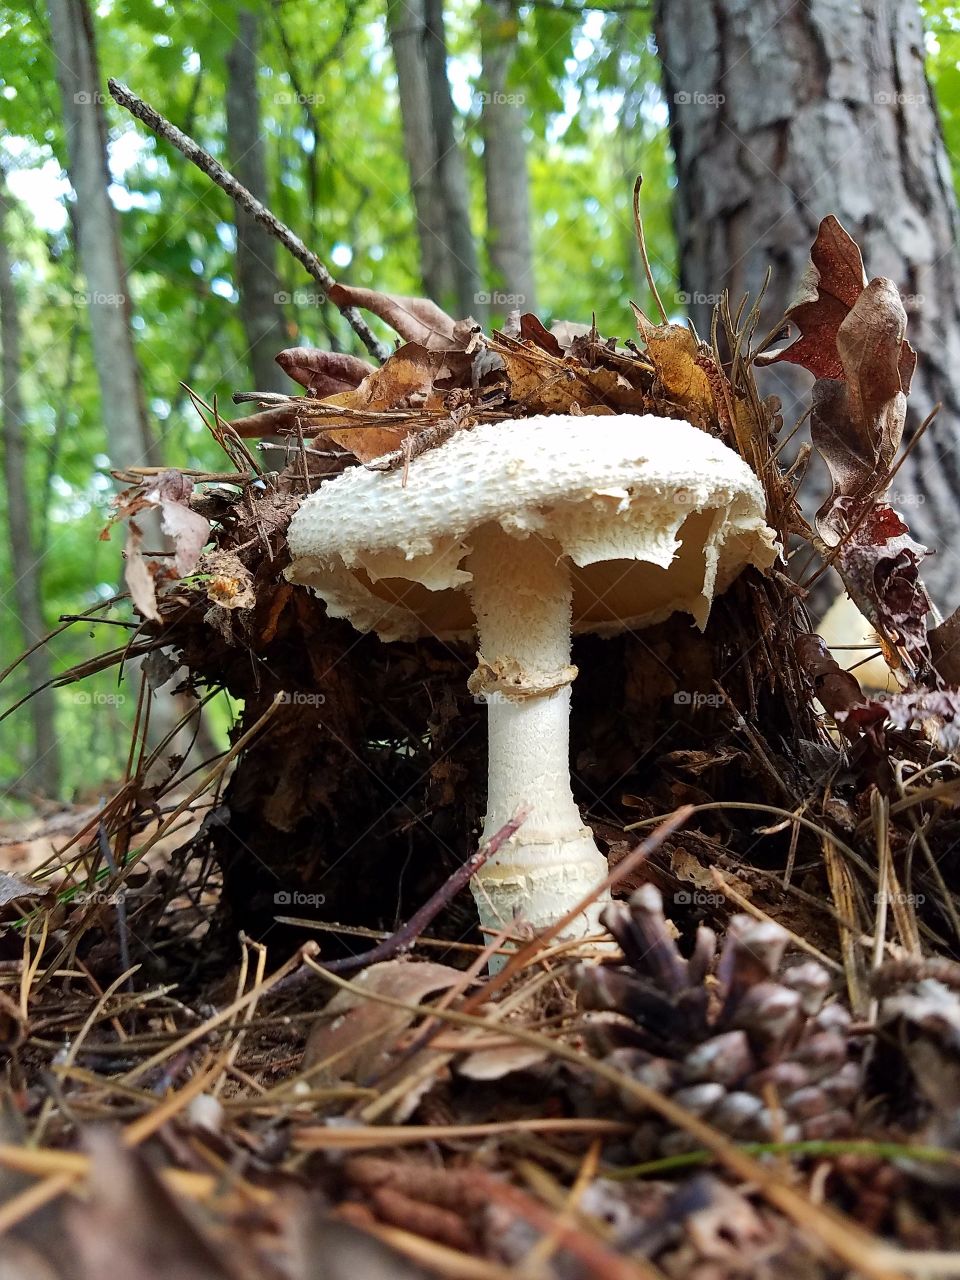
[387,0,480,316]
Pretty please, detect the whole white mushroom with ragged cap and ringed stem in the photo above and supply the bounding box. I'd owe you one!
[287,415,777,962]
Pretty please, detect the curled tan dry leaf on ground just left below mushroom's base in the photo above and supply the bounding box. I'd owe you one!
[303,960,463,1084]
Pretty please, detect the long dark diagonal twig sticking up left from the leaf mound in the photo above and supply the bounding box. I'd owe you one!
[106,79,390,362]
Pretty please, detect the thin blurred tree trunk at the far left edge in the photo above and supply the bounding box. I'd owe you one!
[0,169,60,796]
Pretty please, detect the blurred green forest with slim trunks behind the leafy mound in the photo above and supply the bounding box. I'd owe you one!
[0,0,960,817]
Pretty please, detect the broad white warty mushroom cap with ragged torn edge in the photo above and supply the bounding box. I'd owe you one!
[287,415,777,640]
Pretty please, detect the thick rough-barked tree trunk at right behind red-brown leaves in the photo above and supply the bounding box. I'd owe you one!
[655,0,960,609]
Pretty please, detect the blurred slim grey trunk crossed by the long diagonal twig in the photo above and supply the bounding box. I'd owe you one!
[227,9,291,390]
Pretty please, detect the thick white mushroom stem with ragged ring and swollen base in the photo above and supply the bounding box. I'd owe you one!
[466,525,607,952]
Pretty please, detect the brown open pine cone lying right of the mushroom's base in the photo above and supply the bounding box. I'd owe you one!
[579,884,863,1158]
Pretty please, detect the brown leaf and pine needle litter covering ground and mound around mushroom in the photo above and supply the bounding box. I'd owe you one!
[0,209,960,1280]
